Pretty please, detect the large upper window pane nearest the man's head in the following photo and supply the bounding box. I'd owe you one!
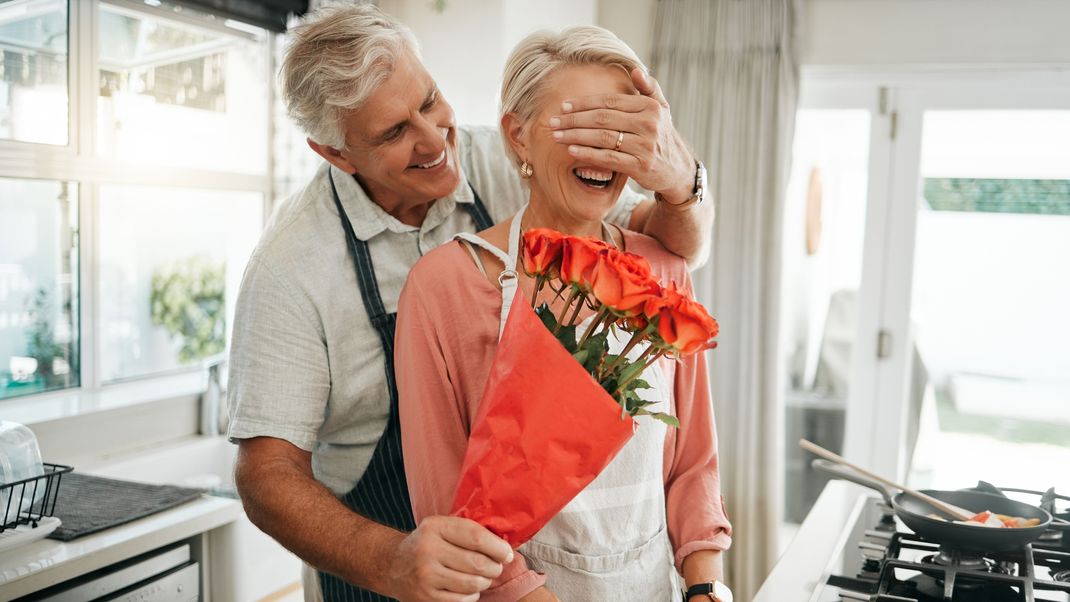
[96,3,270,175]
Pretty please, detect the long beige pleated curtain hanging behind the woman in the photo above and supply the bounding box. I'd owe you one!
[652,0,798,600]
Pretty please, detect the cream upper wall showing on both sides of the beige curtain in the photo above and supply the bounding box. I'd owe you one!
[597,0,1070,66]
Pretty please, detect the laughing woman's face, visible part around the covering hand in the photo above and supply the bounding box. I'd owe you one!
[506,65,639,227]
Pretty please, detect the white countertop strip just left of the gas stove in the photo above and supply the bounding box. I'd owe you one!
[753,480,873,602]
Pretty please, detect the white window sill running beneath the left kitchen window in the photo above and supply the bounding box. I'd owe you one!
[0,370,208,426]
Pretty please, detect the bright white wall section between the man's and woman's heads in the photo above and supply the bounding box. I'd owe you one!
[379,0,597,125]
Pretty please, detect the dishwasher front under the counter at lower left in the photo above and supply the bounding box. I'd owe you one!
[15,543,201,602]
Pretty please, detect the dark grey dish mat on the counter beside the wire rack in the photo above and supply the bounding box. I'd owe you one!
[48,473,204,541]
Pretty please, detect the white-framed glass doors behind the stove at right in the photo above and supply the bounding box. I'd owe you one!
[782,72,1070,522]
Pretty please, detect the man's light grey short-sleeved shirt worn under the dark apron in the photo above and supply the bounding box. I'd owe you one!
[228,127,642,495]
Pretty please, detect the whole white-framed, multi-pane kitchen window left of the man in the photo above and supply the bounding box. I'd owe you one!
[0,0,277,414]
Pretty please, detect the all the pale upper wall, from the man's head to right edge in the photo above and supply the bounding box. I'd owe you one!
[370,0,1070,125]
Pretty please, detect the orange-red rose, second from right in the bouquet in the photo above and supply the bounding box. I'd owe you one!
[591,249,660,318]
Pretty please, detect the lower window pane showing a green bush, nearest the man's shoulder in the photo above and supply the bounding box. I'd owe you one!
[96,185,262,383]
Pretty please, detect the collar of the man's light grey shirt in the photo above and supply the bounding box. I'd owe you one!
[328,166,475,242]
